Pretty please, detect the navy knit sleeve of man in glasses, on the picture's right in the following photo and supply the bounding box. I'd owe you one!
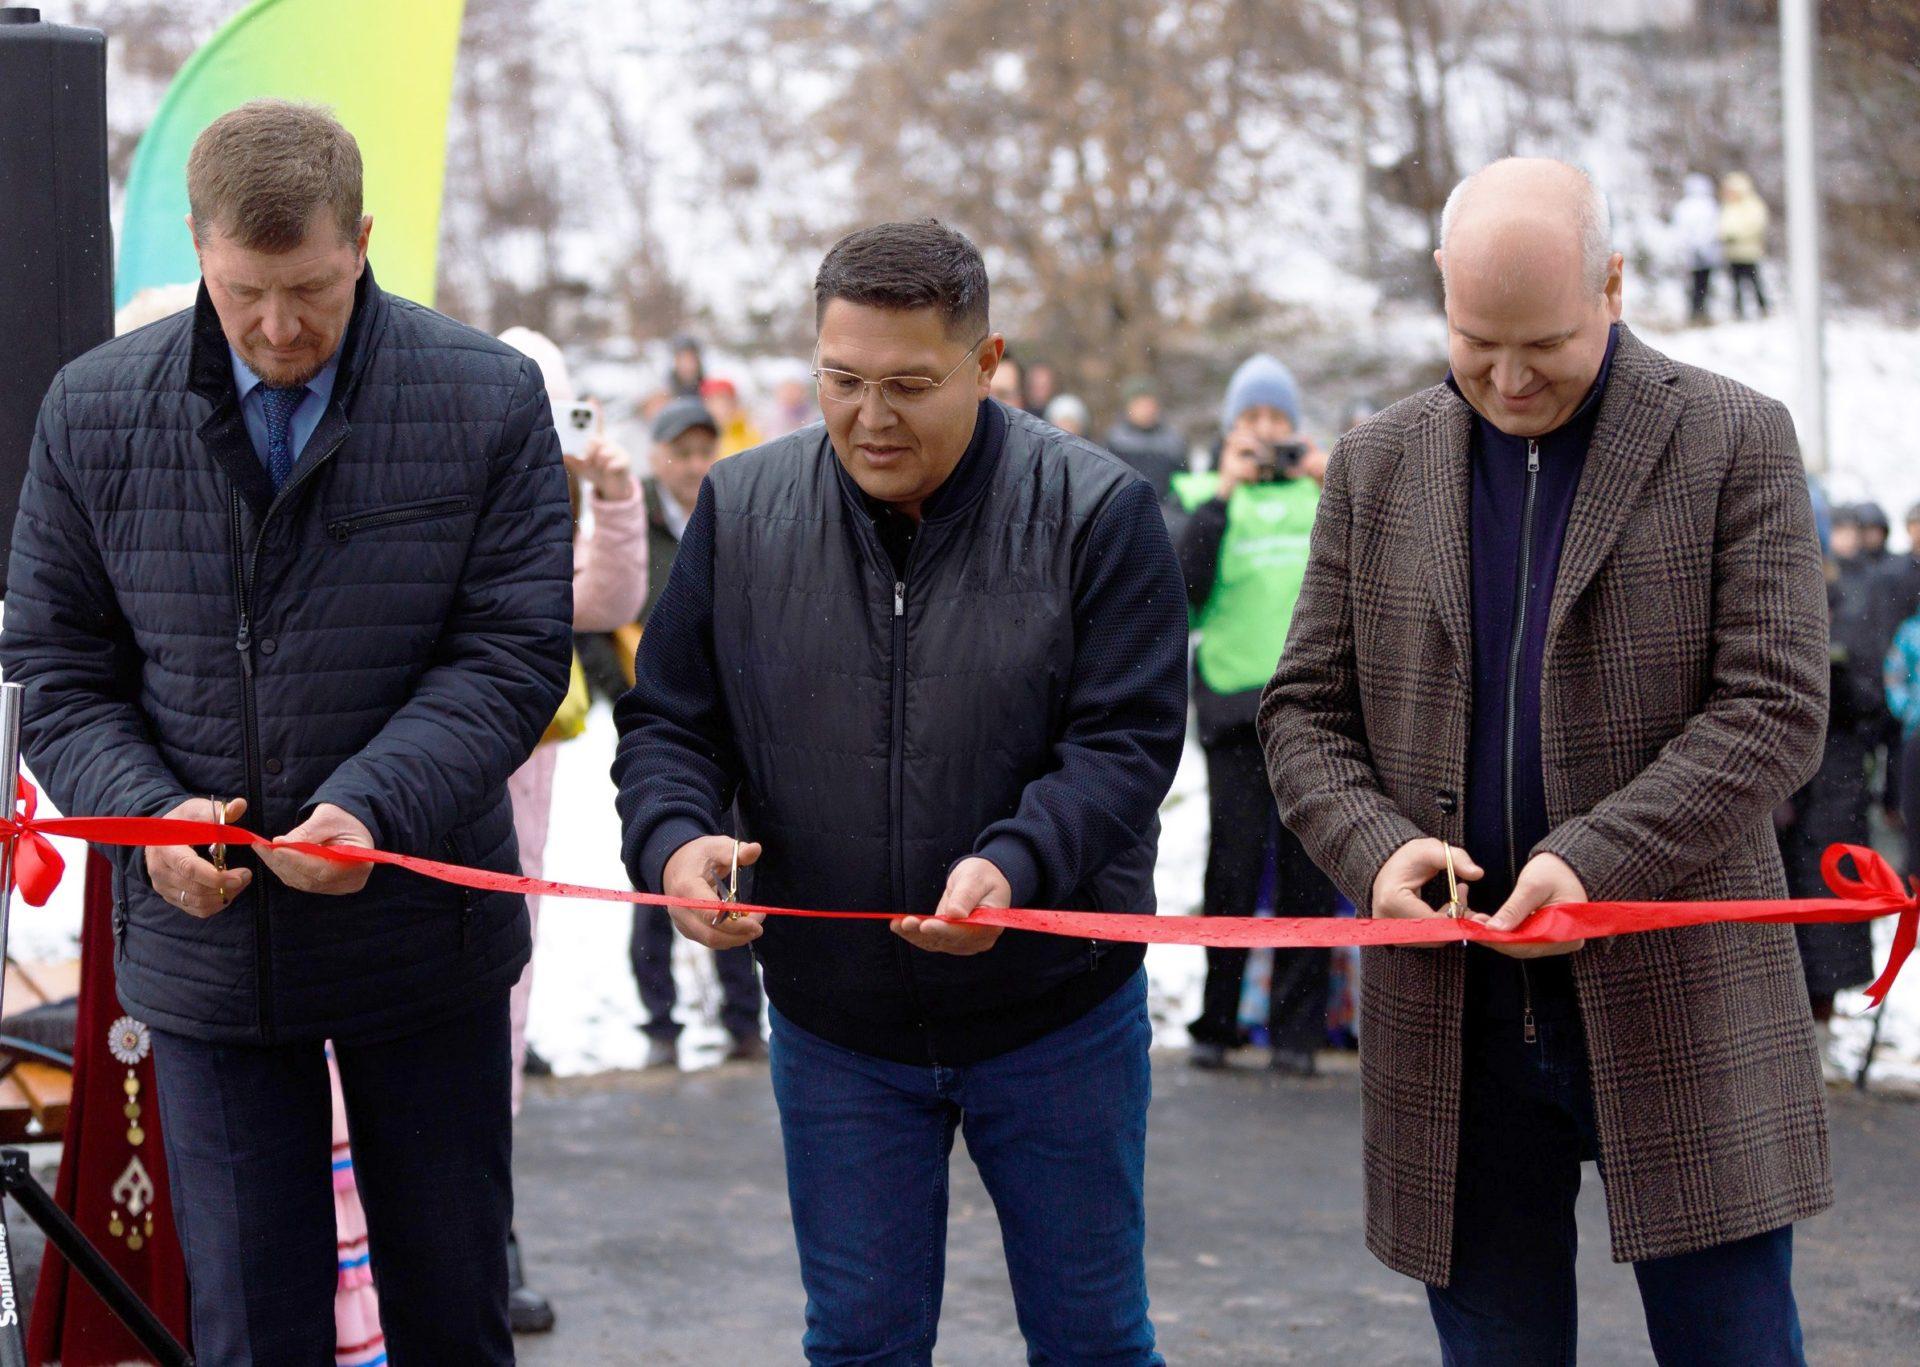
[975,482,1187,910]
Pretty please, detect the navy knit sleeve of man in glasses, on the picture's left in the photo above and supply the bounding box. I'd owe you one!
[612,484,739,893]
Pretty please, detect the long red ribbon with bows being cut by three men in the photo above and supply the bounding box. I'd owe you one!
[0,794,1920,1006]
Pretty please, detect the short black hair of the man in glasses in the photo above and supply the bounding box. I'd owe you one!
[814,219,987,334]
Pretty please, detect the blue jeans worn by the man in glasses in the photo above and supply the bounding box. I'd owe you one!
[772,971,1162,1367]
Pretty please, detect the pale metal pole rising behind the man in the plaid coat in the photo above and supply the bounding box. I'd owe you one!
[1780,0,1828,474]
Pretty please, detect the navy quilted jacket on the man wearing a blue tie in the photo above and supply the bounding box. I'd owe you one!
[0,271,572,1043]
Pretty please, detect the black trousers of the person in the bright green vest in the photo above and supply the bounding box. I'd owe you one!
[1188,726,1334,1052]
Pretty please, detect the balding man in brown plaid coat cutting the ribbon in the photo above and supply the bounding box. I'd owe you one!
[1260,161,1832,1363]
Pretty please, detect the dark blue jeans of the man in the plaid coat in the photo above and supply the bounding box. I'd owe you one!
[1427,1014,1805,1367]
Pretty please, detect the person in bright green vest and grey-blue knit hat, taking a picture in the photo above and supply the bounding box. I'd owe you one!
[1173,355,1334,1075]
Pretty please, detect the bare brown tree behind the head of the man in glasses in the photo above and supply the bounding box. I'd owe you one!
[707,0,1344,405]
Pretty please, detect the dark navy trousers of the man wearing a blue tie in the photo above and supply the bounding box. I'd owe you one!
[154,993,513,1367]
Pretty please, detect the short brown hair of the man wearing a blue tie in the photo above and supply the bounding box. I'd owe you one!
[186,100,361,252]
